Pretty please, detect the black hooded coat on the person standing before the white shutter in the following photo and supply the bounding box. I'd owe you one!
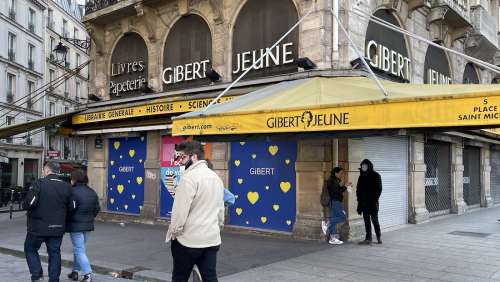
[356,159,382,211]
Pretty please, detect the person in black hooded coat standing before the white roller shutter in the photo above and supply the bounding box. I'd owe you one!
[356,159,382,245]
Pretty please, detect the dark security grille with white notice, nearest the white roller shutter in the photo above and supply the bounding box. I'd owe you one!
[424,140,451,216]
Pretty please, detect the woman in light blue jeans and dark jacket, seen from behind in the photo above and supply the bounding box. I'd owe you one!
[66,169,100,282]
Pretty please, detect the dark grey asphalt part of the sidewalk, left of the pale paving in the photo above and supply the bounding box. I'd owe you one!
[0,212,325,281]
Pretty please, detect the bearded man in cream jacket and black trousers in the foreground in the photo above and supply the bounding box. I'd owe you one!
[167,141,224,282]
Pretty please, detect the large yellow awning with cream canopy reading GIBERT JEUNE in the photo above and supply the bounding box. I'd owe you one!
[172,77,500,136]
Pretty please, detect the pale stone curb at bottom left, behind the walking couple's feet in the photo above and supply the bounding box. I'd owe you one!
[0,245,172,282]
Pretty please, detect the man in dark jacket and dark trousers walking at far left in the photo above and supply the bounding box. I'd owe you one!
[23,162,71,282]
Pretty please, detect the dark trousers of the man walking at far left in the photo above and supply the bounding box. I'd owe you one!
[24,233,63,282]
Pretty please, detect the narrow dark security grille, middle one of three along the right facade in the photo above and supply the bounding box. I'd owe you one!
[463,146,481,206]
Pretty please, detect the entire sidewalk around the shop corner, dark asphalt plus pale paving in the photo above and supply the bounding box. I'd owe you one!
[0,207,500,282]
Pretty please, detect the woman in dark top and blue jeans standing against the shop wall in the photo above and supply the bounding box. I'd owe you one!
[327,167,351,245]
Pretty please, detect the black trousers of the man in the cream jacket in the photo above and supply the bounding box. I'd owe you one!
[170,240,220,282]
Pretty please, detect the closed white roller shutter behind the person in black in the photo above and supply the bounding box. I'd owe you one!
[364,137,408,228]
